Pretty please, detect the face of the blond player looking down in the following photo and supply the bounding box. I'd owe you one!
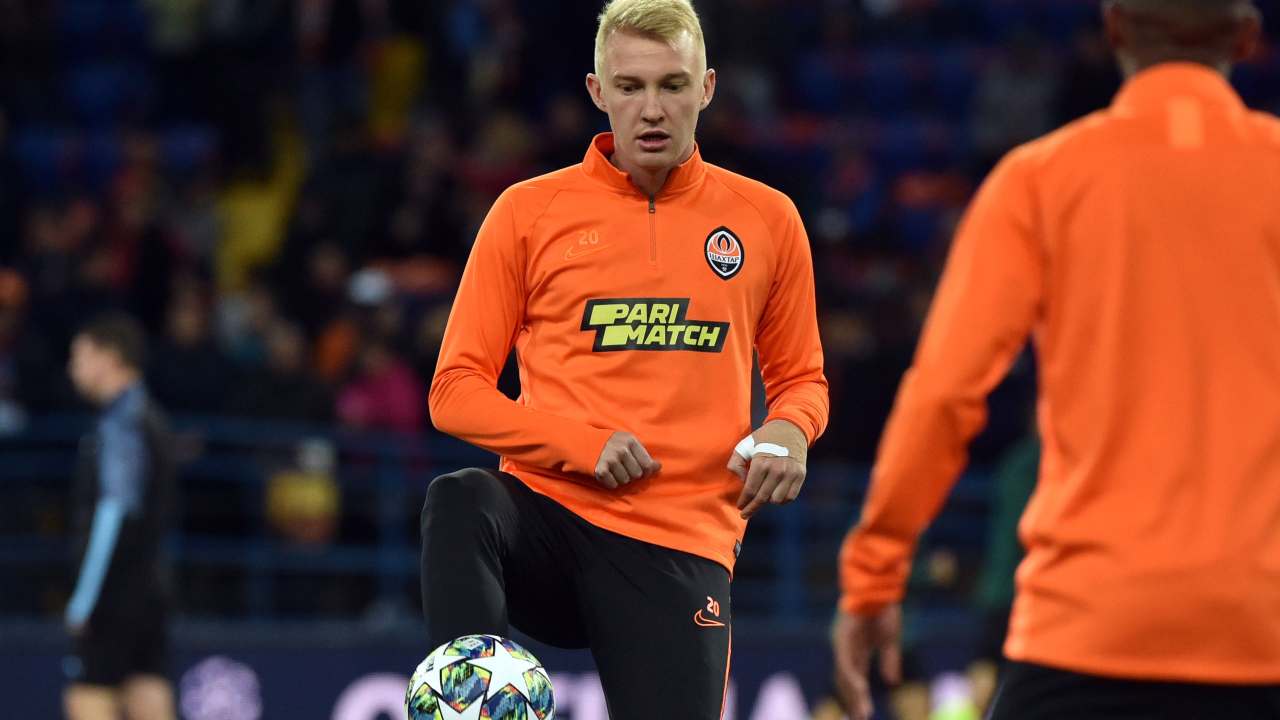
[586,32,716,179]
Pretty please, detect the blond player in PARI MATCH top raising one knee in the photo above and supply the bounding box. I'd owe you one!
[421,0,827,720]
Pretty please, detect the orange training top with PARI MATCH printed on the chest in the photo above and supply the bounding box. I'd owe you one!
[430,135,827,570]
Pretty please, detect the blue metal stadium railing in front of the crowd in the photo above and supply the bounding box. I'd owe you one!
[0,415,989,634]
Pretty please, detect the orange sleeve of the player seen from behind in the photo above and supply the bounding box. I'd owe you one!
[840,152,1044,614]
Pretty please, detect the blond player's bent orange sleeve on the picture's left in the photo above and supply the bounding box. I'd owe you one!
[429,191,613,475]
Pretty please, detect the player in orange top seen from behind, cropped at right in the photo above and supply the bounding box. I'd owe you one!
[833,0,1280,720]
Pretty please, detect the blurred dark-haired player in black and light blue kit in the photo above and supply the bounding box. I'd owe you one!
[64,314,174,720]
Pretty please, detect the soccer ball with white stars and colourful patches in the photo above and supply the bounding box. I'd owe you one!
[404,635,556,720]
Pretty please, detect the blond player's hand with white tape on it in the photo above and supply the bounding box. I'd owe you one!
[728,420,809,518]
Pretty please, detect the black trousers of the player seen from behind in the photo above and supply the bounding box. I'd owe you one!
[988,661,1280,720]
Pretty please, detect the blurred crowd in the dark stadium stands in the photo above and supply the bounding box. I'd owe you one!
[0,0,1280,712]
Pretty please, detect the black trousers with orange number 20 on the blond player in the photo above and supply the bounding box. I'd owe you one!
[421,469,731,720]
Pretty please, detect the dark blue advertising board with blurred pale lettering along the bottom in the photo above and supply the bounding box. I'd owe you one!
[0,620,831,720]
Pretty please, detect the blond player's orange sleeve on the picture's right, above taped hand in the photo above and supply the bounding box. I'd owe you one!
[755,200,829,445]
